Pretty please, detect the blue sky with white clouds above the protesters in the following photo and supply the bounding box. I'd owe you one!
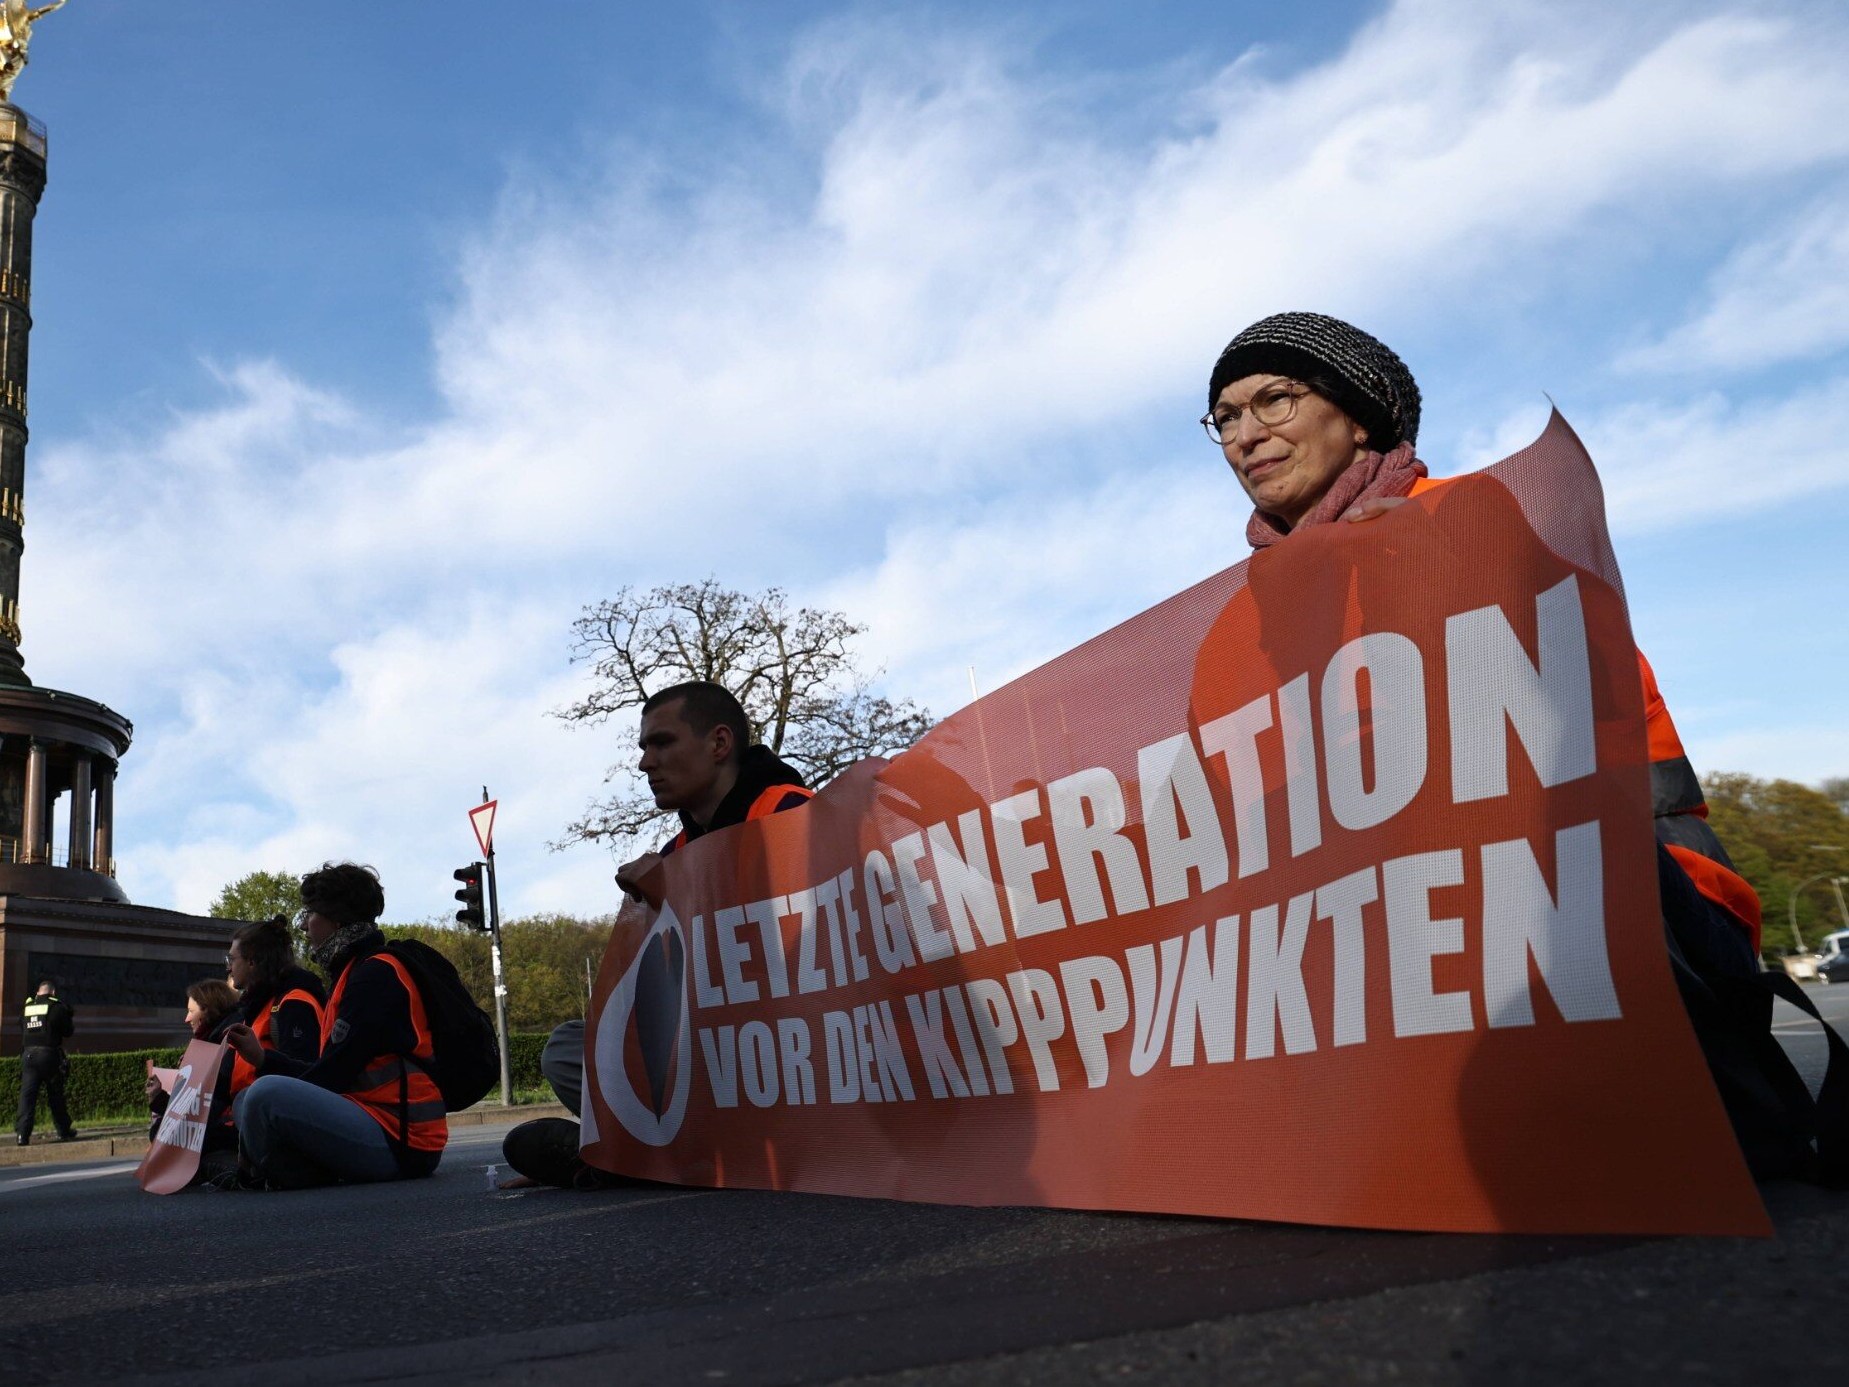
[15,0,1849,917]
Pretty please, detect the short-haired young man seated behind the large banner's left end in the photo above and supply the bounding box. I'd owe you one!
[501,681,815,1187]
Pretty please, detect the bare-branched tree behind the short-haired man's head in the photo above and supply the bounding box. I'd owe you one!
[553,577,932,851]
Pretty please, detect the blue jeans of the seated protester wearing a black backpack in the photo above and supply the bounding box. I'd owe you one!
[237,1074,401,1185]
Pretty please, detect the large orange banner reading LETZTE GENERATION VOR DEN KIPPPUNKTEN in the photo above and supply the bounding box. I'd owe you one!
[584,416,1769,1234]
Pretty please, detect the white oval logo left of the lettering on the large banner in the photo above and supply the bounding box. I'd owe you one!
[597,904,693,1147]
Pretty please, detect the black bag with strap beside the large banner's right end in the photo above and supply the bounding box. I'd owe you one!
[1657,845,1849,1187]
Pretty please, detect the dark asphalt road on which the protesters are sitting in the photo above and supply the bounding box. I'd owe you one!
[0,988,1849,1387]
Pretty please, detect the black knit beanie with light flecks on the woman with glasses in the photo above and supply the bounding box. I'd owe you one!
[1207,313,1418,453]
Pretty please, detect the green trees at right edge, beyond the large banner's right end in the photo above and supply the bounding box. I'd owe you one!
[1701,771,1849,958]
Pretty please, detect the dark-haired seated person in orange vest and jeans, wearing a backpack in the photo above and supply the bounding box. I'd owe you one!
[227,862,449,1189]
